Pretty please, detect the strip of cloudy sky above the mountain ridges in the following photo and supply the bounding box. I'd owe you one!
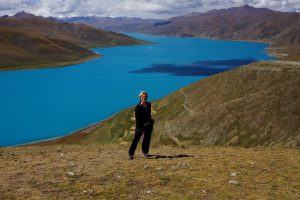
[0,0,300,19]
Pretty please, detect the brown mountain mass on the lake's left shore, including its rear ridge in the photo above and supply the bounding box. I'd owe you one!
[0,12,145,70]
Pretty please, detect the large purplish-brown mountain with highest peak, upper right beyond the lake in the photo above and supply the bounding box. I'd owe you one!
[142,5,300,60]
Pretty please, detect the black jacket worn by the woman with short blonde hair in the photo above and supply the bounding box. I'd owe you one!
[135,102,154,129]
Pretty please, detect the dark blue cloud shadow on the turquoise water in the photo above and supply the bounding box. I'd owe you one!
[131,58,257,76]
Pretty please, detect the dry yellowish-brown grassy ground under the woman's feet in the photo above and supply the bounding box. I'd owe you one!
[0,144,300,200]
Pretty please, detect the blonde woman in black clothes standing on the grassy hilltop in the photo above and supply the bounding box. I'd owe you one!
[129,91,154,160]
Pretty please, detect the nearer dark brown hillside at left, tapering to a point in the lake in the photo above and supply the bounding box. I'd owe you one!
[0,28,97,70]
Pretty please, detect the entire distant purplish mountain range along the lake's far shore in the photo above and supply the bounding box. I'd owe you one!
[66,5,300,60]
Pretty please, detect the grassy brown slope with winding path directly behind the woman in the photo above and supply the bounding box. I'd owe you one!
[40,61,300,148]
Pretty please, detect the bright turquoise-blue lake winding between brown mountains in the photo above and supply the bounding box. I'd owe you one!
[0,34,272,146]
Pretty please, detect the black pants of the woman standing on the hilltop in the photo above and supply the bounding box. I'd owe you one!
[129,127,152,155]
